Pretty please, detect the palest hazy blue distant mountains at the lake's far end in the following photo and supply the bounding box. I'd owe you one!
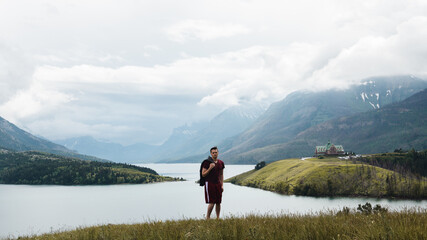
[56,104,266,163]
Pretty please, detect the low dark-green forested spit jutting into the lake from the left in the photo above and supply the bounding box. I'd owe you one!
[0,149,178,185]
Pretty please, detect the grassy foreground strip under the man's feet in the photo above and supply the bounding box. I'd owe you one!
[11,209,427,240]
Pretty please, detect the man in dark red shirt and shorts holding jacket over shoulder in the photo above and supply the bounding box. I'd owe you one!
[202,147,225,219]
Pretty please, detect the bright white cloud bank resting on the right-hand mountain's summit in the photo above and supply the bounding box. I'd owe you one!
[309,16,427,90]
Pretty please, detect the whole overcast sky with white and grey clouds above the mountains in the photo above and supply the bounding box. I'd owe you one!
[0,0,427,145]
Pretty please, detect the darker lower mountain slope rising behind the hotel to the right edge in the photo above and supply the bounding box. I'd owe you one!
[234,86,427,162]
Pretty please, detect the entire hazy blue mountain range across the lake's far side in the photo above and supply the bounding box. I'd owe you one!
[0,76,427,163]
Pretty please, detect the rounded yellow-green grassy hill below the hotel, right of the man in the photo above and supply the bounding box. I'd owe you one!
[227,158,427,199]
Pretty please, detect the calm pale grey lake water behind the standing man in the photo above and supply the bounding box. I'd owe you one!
[0,164,427,238]
